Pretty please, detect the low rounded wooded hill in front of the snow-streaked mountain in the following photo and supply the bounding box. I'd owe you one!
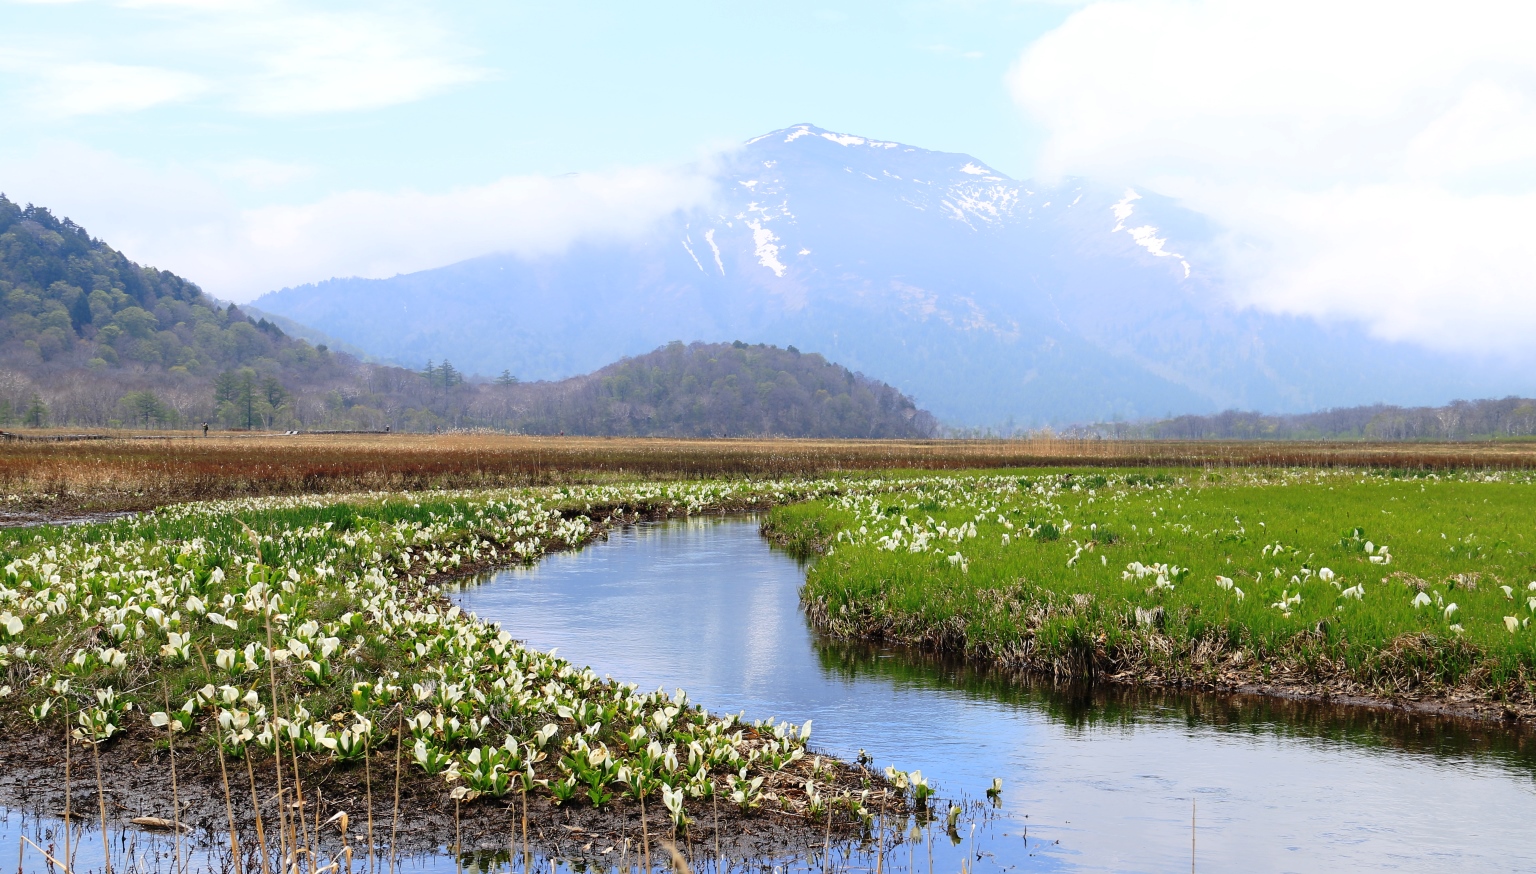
[496,341,937,438]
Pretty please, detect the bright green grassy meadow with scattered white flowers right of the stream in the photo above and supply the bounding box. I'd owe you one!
[770,470,1536,702]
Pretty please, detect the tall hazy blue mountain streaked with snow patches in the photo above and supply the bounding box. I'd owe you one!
[258,124,1533,425]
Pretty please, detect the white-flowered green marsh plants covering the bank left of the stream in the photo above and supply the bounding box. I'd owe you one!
[0,481,903,869]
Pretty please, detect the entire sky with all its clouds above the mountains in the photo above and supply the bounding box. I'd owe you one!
[0,0,1536,355]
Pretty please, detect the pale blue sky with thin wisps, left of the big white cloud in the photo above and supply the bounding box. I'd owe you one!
[0,2,1071,206]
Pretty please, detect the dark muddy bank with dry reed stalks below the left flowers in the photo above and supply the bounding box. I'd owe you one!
[0,720,908,869]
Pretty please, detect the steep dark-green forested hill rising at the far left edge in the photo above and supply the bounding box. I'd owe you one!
[0,195,352,427]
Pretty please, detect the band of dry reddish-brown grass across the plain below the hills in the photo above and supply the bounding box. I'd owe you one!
[0,432,1536,518]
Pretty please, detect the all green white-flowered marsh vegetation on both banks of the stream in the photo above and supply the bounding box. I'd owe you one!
[0,468,1536,868]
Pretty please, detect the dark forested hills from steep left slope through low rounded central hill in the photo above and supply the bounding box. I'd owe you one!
[0,195,932,436]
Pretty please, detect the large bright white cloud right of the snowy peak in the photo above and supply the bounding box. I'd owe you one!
[1008,0,1536,355]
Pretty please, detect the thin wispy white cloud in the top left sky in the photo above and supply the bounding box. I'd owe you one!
[0,0,490,115]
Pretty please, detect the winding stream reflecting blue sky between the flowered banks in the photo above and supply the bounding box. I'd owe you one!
[453,518,1536,872]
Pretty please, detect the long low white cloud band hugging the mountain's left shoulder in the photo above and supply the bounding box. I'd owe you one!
[0,143,714,301]
